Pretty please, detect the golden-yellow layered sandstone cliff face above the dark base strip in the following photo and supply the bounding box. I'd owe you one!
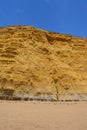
[0,26,87,99]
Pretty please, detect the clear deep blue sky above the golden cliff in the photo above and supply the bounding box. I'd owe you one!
[0,0,87,37]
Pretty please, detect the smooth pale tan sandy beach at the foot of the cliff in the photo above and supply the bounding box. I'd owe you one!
[0,101,87,130]
